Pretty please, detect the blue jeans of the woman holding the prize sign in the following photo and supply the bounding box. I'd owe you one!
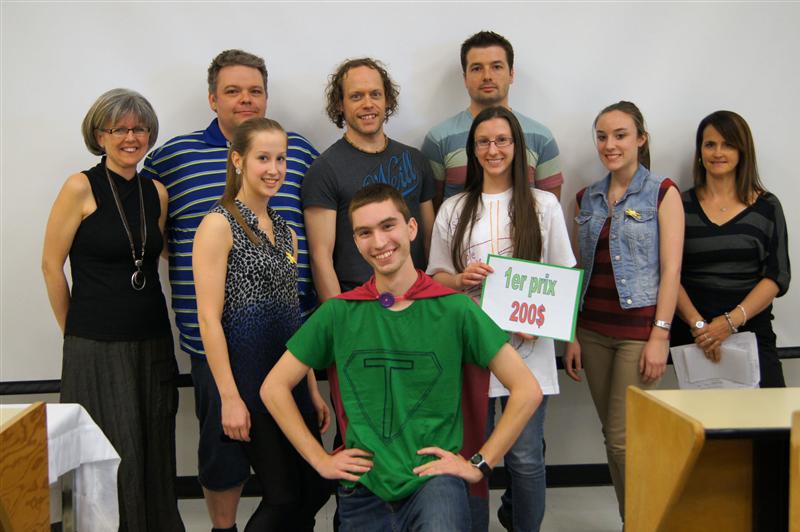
[486,395,547,532]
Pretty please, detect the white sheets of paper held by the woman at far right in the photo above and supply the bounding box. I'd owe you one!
[670,332,760,388]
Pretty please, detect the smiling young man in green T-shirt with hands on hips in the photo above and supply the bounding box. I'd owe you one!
[261,184,542,532]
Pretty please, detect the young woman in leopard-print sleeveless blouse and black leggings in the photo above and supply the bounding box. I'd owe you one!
[192,118,330,532]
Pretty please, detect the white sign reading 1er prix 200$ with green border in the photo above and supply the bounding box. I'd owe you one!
[481,255,583,342]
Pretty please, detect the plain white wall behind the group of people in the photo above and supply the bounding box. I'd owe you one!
[0,2,800,470]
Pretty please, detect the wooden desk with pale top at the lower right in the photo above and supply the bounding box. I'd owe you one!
[625,387,800,532]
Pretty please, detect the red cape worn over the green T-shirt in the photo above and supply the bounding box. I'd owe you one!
[328,270,490,498]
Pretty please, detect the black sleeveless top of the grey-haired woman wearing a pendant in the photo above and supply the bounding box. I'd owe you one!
[64,157,172,340]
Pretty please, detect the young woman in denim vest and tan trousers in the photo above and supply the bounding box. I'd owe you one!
[565,101,684,519]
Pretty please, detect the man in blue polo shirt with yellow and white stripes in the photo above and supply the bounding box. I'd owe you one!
[142,50,319,531]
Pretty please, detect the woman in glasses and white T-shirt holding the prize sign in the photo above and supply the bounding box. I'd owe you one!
[428,107,575,531]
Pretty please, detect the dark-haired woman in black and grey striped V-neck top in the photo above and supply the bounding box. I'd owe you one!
[672,111,791,387]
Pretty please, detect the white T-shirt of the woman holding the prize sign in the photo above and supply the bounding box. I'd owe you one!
[428,189,575,397]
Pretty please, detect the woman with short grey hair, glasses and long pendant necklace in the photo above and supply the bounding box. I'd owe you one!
[42,89,184,532]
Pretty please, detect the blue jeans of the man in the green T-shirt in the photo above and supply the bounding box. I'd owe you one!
[338,475,470,532]
